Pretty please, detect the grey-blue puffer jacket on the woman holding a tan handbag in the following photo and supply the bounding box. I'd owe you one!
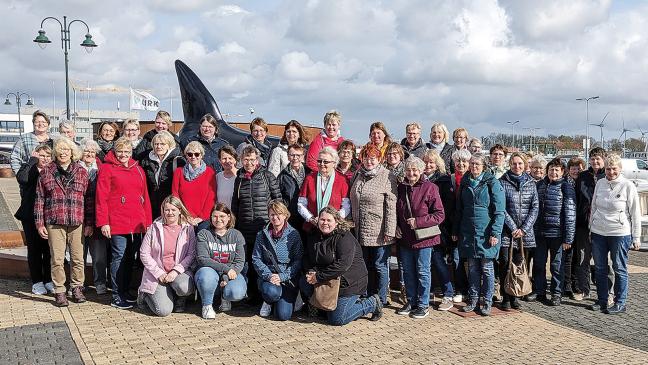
[499,171,539,248]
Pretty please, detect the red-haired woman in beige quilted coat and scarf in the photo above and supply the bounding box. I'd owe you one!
[350,144,398,305]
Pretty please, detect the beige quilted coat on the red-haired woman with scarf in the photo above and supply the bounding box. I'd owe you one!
[349,165,398,247]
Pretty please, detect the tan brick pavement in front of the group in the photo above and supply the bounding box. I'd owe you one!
[0,277,648,364]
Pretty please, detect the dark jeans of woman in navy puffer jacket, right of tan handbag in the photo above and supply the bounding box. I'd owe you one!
[533,235,566,296]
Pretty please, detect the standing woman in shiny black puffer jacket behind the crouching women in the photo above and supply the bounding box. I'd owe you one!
[232,146,281,304]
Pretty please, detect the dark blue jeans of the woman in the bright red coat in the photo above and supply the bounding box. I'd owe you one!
[110,233,142,300]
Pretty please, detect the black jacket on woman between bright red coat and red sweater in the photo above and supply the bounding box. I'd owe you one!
[140,146,185,219]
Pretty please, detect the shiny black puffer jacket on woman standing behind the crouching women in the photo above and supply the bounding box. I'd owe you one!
[232,167,281,242]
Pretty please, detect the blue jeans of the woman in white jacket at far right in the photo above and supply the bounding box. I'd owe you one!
[592,233,632,306]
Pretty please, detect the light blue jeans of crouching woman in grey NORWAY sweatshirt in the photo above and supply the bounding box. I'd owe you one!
[194,266,247,306]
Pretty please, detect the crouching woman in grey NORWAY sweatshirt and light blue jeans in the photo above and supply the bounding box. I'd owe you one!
[196,203,247,319]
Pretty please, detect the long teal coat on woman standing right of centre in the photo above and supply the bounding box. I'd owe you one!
[453,171,506,259]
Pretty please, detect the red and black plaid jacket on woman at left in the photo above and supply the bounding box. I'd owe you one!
[34,162,92,228]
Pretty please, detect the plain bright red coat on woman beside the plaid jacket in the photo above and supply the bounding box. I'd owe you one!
[95,153,152,234]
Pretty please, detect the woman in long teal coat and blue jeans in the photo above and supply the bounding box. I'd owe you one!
[452,154,506,316]
